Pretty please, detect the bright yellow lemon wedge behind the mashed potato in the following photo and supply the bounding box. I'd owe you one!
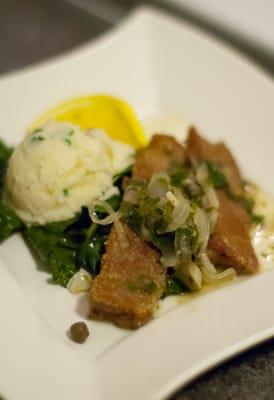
[29,95,148,148]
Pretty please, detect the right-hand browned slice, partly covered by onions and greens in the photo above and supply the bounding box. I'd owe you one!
[186,128,258,273]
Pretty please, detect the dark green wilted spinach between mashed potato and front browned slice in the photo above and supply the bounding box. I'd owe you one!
[24,192,120,287]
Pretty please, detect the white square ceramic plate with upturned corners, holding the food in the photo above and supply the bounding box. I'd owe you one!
[0,8,274,400]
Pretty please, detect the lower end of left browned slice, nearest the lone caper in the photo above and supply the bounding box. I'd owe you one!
[90,224,165,329]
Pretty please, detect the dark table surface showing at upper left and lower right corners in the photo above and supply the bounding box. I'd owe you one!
[0,0,274,400]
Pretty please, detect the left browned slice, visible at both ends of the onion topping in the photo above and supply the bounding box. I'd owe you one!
[90,135,185,329]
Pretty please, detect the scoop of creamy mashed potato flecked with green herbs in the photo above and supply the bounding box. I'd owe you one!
[4,120,134,225]
